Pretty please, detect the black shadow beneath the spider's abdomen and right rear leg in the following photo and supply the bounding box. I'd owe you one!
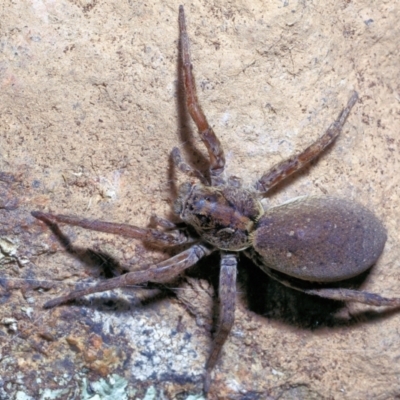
[238,258,400,330]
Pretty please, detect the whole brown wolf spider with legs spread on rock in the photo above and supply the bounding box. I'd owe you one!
[32,6,400,391]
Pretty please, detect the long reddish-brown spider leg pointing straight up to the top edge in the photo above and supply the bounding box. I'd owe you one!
[179,6,225,186]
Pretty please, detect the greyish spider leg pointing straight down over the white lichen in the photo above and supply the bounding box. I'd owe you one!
[204,252,237,392]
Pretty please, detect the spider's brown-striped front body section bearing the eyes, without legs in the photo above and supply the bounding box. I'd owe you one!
[174,183,263,251]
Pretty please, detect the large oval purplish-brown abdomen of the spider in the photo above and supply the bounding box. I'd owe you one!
[253,197,386,282]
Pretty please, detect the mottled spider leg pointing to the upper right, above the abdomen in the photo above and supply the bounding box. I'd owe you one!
[256,92,358,193]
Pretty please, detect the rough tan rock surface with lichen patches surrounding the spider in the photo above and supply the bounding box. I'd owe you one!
[0,0,400,400]
